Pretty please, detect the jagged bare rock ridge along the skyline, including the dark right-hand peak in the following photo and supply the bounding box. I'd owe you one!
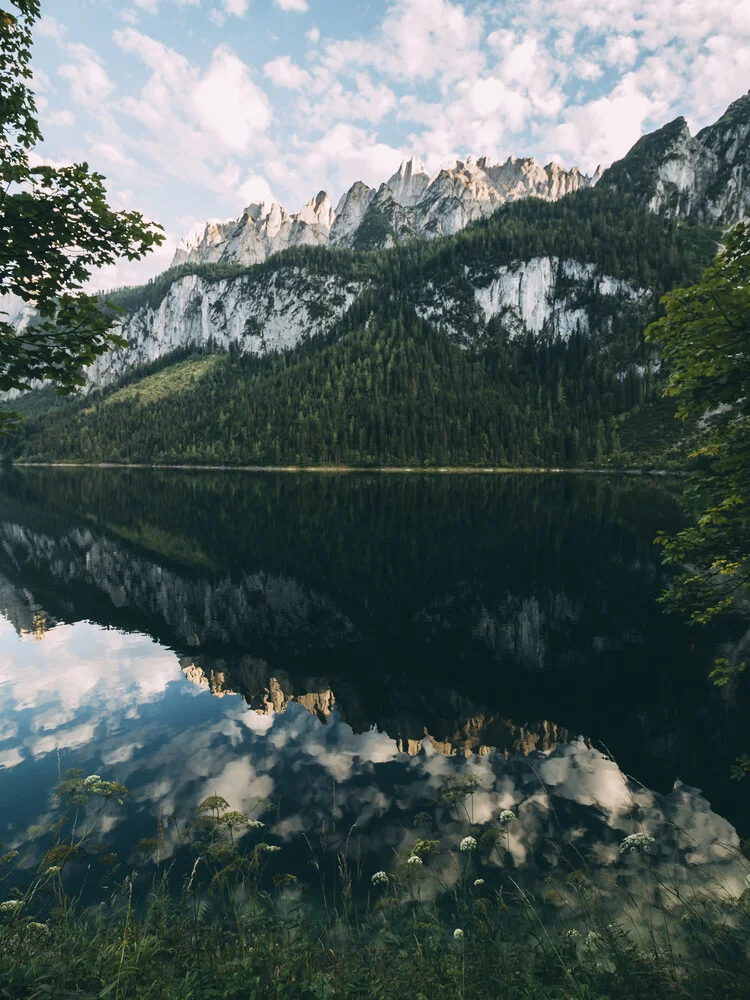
[172,93,750,265]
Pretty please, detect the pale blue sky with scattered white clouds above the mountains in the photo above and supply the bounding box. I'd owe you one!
[26,0,750,288]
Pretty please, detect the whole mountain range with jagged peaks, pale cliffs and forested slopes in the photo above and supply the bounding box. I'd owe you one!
[6,94,750,464]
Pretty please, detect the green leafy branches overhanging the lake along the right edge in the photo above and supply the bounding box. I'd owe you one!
[647,223,750,684]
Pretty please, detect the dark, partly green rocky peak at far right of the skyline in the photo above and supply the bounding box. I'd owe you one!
[602,93,750,226]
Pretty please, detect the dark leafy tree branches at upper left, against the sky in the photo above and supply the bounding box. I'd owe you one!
[0,0,164,427]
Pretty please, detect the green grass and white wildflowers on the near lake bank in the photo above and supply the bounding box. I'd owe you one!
[0,772,750,1000]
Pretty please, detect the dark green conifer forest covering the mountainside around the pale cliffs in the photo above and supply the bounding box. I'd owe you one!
[5,189,718,466]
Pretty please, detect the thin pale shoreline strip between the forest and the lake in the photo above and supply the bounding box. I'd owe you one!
[7,462,688,477]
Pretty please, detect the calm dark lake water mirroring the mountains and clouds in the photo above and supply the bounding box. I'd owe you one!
[0,469,750,904]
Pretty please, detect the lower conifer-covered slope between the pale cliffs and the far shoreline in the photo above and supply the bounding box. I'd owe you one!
[5,295,696,467]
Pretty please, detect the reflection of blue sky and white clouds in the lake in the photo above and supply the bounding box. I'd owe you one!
[0,621,743,916]
